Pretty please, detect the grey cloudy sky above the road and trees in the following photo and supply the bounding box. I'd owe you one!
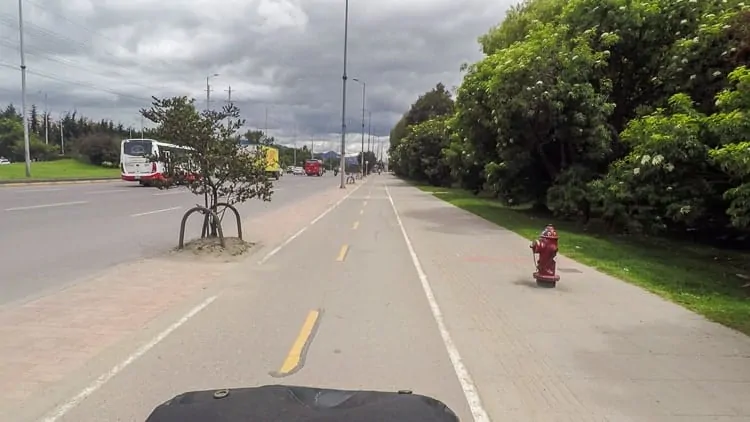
[0,0,513,152]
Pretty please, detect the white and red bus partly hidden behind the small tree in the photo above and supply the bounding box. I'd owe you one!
[120,139,191,186]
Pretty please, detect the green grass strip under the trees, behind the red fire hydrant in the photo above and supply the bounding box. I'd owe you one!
[419,186,750,335]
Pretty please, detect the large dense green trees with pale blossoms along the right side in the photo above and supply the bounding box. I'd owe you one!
[389,0,750,237]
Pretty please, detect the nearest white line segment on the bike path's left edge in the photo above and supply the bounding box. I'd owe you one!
[43,296,216,422]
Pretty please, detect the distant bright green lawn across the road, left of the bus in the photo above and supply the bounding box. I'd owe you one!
[0,159,120,182]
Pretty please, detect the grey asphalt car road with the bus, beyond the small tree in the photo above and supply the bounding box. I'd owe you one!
[0,175,337,305]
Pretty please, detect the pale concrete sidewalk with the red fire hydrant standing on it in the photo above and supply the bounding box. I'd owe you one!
[387,178,750,422]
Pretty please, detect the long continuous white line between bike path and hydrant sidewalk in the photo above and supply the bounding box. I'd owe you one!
[383,183,491,422]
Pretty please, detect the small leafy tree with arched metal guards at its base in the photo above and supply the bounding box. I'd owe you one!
[141,97,273,248]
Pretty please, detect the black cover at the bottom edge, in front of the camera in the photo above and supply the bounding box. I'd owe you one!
[146,385,459,422]
